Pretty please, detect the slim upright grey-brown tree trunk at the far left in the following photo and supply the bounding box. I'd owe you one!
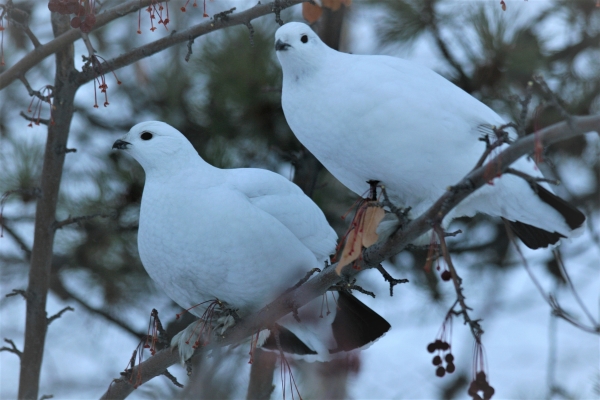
[19,14,77,399]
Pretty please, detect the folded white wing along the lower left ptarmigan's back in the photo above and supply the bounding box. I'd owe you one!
[228,168,337,261]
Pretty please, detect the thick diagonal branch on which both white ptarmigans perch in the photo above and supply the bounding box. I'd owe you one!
[102,115,600,399]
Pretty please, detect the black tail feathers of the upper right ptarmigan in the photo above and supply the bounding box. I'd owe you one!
[505,184,585,249]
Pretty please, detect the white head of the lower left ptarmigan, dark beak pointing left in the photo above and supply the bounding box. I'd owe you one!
[112,121,200,173]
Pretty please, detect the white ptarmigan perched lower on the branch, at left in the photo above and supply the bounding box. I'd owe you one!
[113,121,390,361]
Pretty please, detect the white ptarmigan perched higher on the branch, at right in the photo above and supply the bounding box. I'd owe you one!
[275,22,585,249]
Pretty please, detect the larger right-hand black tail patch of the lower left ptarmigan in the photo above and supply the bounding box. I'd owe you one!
[329,292,391,354]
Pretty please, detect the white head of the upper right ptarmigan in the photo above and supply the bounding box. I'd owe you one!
[275,22,329,77]
